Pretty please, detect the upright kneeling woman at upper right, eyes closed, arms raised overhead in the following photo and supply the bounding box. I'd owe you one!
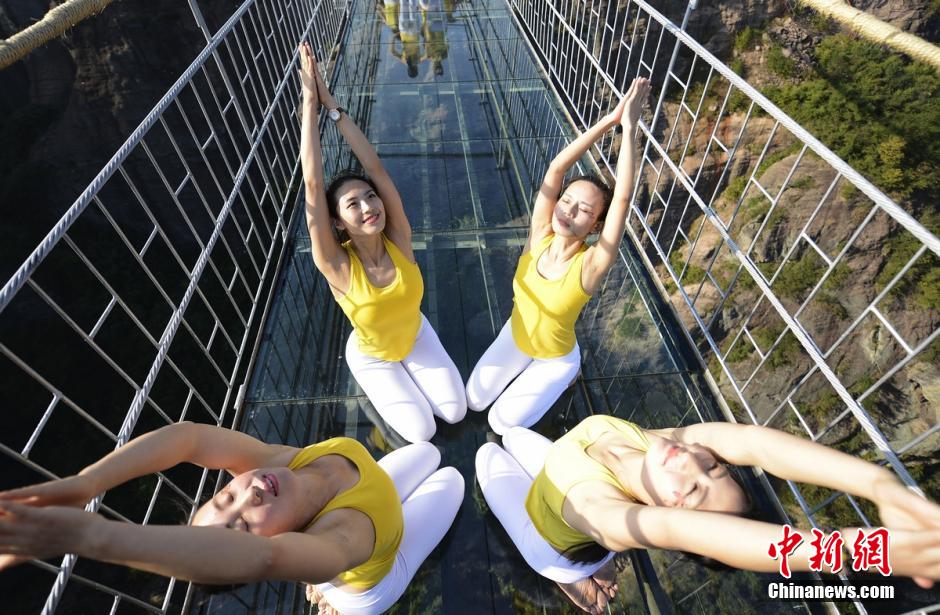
[467,78,650,434]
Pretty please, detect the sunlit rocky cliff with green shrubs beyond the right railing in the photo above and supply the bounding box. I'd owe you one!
[638,2,940,520]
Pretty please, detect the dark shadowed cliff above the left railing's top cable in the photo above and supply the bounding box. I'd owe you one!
[0,0,233,279]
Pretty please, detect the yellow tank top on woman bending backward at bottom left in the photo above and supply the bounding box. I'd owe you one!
[287,438,404,589]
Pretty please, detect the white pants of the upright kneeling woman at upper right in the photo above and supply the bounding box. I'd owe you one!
[467,321,581,435]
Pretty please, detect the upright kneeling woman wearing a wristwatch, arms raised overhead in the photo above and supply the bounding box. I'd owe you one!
[300,45,467,442]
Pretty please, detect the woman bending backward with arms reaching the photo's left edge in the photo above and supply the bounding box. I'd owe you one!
[0,423,464,615]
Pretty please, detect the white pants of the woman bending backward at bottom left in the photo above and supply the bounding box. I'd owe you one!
[317,442,464,615]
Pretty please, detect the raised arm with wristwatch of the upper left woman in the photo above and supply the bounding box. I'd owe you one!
[317,67,414,260]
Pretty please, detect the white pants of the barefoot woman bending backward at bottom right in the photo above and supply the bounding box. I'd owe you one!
[476,427,614,583]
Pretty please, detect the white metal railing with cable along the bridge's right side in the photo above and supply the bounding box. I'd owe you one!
[510,0,940,608]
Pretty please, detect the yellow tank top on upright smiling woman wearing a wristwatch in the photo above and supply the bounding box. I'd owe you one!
[338,233,424,361]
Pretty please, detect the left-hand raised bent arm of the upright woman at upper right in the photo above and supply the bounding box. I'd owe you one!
[523,100,624,252]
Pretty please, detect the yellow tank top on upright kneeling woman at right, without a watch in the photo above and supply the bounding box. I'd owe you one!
[510,234,591,359]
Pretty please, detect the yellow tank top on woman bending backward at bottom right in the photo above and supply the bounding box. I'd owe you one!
[525,414,649,553]
